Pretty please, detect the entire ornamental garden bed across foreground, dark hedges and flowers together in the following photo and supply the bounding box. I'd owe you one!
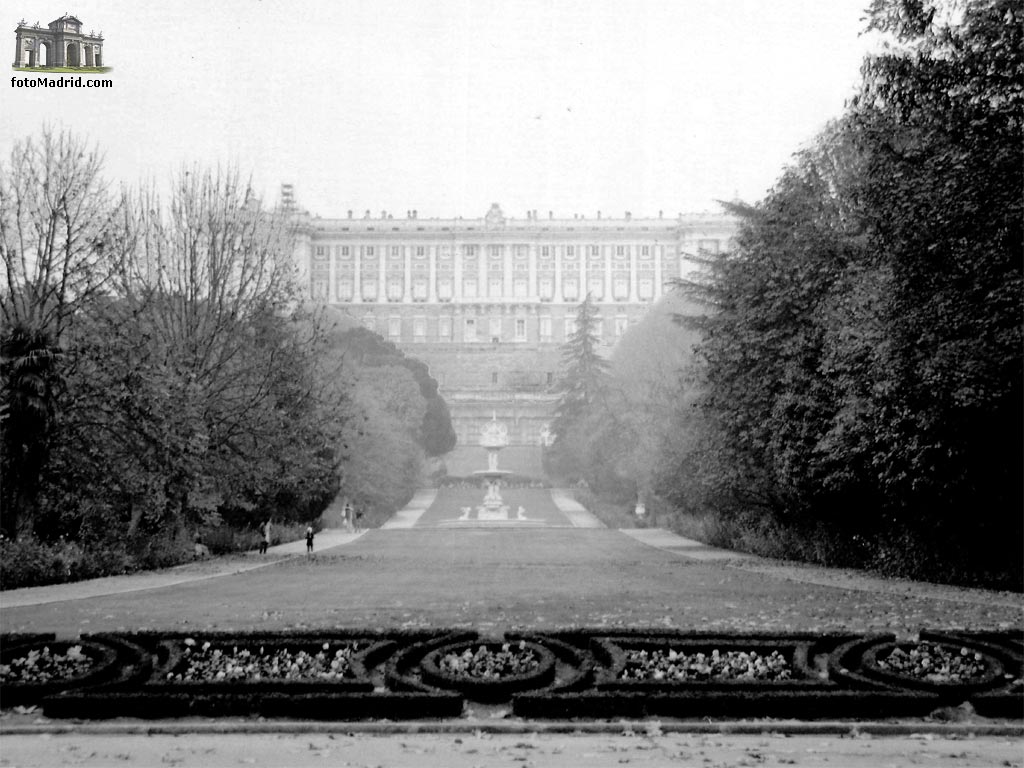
[0,629,1024,720]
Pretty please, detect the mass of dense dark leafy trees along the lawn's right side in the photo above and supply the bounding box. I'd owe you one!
[671,0,1024,584]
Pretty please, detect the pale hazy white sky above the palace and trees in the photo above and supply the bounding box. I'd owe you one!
[0,0,868,217]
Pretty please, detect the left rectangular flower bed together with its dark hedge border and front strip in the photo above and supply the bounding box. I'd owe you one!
[43,631,463,720]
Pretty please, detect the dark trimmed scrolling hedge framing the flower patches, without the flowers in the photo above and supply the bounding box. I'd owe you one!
[0,629,1024,720]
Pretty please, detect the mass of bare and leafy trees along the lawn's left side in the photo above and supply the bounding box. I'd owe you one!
[0,130,455,586]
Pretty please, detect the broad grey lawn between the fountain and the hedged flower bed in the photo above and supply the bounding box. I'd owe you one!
[0,511,1024,635]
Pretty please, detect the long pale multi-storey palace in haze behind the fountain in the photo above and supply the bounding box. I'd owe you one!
[287,199,735,474]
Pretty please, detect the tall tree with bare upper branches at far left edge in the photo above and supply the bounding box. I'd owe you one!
[0,128,116,538]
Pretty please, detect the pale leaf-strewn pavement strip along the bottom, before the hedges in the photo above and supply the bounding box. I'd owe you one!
[0,724,1024,768]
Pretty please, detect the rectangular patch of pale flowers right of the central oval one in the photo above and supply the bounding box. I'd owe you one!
[620,649,792,681]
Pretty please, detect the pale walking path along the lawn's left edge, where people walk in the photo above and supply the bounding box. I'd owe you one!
[0,529,362,608]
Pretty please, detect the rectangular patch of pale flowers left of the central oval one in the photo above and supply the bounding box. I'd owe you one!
[167,638,359,682]
